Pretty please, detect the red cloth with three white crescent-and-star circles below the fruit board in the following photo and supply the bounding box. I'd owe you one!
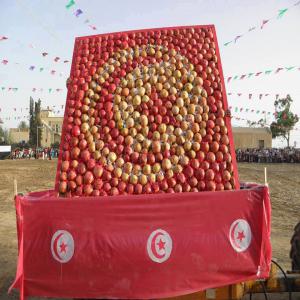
[9,186,271,299]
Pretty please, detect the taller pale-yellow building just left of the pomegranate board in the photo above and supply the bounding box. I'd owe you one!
[39,109,63,147]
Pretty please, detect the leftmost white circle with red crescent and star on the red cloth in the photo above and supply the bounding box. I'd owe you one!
[51,230,74,263]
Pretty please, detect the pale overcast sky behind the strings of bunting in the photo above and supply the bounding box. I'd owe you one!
[0,0,300,147]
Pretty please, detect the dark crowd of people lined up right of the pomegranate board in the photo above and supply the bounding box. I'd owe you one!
[235,148,300,163]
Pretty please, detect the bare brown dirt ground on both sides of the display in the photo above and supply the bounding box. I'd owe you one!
[0,160,300,299]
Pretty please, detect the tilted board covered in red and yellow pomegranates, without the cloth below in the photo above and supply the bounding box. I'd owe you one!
[55,25,239,196]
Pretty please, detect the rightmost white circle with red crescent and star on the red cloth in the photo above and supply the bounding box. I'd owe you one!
[229,219,252,252]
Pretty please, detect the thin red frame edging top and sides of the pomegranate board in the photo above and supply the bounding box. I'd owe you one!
[55,24,240,194]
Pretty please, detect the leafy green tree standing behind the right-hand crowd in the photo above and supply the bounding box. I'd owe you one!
[270,95,299,147]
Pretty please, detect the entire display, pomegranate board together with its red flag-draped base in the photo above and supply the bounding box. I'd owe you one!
[12,26,271,300]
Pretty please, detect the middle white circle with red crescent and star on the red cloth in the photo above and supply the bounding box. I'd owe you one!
[147,229,172,263]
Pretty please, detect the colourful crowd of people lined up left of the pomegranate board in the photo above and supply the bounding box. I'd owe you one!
[11,147,59,159]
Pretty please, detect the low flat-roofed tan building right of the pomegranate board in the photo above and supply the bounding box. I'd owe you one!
[232,127,272,149]
